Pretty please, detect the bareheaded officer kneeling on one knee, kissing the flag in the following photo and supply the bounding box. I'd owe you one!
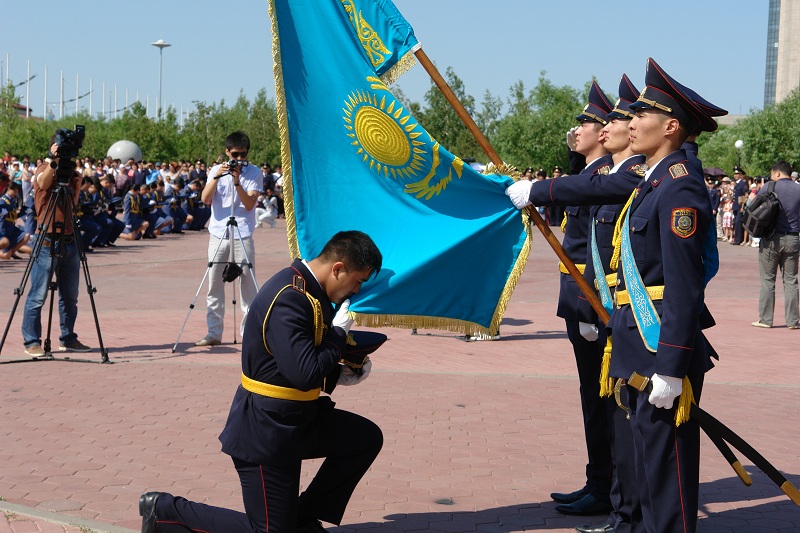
[139,231,385,533]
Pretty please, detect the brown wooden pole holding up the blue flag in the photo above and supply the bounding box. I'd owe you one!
[414,48,611,324]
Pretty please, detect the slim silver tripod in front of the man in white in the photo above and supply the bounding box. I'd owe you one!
[172,172,258,353]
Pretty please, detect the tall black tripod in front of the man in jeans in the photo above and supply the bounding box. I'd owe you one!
[0,172,110,364]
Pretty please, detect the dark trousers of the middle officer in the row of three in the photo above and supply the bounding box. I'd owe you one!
[608,387,645,533]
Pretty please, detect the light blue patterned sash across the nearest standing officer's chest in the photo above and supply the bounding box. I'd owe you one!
[620,209,661,352]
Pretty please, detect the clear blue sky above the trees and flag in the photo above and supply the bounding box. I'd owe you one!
[0,0,768,120]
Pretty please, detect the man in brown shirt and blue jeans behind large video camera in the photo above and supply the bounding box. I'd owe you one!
[22,135,91,357]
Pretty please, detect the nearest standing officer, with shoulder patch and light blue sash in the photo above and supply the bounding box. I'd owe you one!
[509,59,725,533]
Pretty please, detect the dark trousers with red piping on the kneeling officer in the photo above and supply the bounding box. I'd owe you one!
[156,409,383,533]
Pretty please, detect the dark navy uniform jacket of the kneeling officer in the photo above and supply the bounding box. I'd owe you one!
[219,260,346,464]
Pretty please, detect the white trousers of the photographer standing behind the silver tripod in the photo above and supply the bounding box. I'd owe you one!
[206,234,258,340]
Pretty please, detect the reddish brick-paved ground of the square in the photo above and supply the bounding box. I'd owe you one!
[0,220,800,533]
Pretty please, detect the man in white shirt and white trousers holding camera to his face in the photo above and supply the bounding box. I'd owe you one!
[195,131,261,346]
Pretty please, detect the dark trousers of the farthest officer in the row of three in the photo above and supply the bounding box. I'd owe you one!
[565,320,613,501]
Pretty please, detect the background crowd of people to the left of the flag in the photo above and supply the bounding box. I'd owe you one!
[0,151,284,259]
